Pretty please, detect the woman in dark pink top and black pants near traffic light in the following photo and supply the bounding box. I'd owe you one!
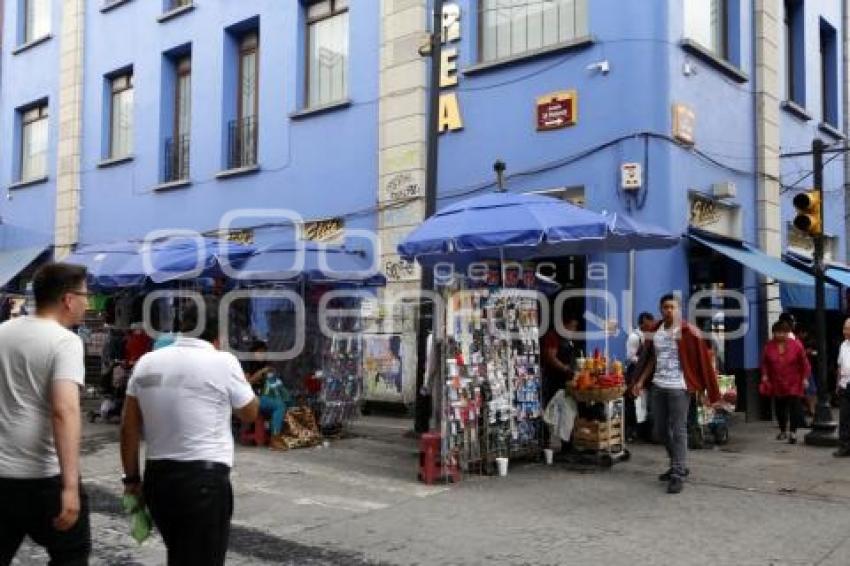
[761,322,812,444]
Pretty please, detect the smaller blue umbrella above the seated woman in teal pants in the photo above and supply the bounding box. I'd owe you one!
[237,240,386,287]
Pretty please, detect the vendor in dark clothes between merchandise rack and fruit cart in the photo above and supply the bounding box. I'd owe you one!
[541,313,579,450]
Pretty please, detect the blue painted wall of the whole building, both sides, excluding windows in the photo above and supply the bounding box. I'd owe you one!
[0,0,845,367]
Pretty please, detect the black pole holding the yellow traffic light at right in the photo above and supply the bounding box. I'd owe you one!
[805,139,838,446]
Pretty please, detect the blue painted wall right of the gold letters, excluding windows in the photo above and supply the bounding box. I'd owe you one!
[440,0,844,367]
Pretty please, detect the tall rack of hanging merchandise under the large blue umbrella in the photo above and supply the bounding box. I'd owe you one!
[442,264,542,473]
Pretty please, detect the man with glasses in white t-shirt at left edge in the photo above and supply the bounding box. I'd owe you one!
[0,263,91,565]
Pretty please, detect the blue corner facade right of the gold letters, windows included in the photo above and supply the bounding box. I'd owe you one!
[440,0,847,370]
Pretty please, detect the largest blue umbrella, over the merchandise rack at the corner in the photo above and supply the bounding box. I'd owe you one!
[398,193,678,264]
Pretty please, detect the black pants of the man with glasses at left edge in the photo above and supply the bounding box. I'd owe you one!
[0,476,91,566]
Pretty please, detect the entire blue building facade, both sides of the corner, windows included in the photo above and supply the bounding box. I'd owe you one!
[0,0,848,382]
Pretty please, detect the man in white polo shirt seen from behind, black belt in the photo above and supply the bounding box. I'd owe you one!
[121,308,259,566]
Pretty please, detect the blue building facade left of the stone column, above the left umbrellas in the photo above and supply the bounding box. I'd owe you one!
[0,0,380,252]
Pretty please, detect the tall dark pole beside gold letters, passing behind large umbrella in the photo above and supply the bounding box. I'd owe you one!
[414,0,443,434]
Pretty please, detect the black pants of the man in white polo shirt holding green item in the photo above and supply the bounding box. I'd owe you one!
[144,460,233,566]
